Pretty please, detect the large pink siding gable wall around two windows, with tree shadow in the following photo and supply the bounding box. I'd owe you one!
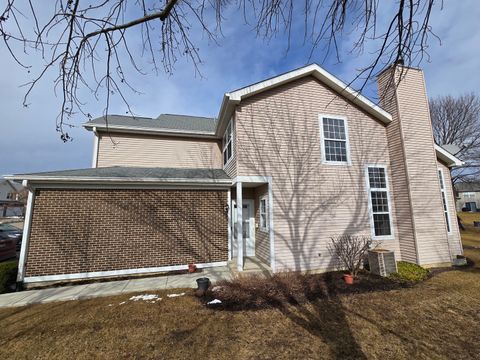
[236,77,401,271]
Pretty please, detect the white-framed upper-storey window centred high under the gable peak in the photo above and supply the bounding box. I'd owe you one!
[320,115,350,165]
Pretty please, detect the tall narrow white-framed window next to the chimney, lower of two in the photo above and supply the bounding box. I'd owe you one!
[366,165,393,240]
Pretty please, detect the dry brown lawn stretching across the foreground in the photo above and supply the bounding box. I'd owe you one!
[0,228,480,359]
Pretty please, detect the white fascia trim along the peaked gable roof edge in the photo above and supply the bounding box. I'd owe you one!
[218,64,392,126]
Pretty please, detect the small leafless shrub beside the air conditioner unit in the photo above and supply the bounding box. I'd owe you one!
[329,235,373,277]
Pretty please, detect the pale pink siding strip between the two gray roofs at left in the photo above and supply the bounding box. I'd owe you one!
[97,133,222,169]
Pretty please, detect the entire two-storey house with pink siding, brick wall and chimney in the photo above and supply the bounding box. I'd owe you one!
[5,65,463,283]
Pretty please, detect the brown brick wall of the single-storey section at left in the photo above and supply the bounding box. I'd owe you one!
[26,189,228,277]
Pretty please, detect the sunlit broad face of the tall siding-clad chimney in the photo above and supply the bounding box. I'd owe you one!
[380,67,451,265]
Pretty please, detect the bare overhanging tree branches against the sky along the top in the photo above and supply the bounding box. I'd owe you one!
[0,0,441,141]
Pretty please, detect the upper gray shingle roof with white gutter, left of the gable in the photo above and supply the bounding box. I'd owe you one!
[83,114,217,135]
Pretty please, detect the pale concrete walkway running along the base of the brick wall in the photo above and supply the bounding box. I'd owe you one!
[0,267,231,308]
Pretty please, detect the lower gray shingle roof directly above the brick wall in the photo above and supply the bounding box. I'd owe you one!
[9,166,230,181]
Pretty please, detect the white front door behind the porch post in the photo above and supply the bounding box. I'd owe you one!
[232,199,255,259]
